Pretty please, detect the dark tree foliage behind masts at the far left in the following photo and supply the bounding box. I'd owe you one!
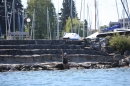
[0,0,23,34]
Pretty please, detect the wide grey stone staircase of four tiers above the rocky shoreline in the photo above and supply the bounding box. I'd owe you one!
[0,40,112,63]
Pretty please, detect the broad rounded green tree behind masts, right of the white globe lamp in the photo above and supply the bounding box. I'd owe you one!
[27,0,55,39]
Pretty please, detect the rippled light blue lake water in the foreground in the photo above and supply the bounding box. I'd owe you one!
[0,68,130,86]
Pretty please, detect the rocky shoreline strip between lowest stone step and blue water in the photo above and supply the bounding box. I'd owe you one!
[0,62,130,72]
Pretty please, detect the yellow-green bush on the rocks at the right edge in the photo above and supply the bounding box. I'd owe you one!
[109,34,130,54]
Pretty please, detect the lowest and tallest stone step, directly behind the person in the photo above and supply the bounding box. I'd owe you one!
[0,54,113,63]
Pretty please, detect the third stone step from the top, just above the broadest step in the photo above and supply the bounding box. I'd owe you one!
[0,49,105,55]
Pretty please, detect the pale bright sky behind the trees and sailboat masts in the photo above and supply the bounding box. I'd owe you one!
[22,0,130,29]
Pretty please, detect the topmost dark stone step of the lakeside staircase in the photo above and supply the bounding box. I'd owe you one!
[0,40,84,45]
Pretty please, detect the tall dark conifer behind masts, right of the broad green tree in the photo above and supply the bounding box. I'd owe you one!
[61,0,77,30]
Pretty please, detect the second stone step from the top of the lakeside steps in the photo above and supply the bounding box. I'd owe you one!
[0,44,84,49]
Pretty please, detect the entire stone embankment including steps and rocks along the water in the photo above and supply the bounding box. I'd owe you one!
[0,40,130,72]
